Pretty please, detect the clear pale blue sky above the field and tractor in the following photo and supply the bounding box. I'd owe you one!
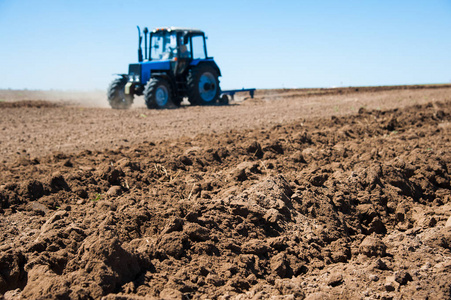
[0,0,451,90]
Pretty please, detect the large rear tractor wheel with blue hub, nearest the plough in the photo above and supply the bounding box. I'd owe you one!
[187,64,220,105]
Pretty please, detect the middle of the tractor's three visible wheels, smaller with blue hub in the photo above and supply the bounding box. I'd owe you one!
[144,77,175,108]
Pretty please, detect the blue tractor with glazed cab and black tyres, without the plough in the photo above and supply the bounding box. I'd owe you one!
[108,27,221,109]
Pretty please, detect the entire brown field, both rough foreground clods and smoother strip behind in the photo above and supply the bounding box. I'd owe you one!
[0,86,451,299]
